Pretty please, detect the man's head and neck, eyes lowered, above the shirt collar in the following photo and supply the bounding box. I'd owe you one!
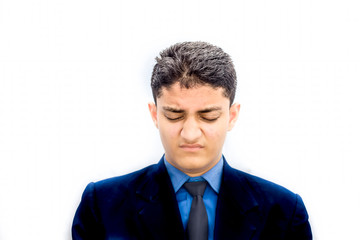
[149,42,240,176]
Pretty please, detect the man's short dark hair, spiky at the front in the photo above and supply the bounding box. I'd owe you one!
[151,42,236,105]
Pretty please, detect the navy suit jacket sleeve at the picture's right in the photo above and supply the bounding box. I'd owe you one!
[286,194,312,240]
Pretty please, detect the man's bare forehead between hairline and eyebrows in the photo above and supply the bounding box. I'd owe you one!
[157,83,230,110]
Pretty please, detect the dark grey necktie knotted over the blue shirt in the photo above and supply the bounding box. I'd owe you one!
[184,181,208,240]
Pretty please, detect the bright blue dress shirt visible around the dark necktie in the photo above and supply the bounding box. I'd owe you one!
[164,157,224,240]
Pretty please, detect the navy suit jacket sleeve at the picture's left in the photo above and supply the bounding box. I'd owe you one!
[72,183,104,240]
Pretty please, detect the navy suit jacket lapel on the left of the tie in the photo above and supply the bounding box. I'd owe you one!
[136,159,184,240]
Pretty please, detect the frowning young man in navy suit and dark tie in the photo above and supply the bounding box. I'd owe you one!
[72,42,312,240]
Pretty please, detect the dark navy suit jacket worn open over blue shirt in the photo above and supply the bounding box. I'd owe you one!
[72,159,312,240]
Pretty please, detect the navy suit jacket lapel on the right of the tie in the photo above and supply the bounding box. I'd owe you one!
[215,161,262,240]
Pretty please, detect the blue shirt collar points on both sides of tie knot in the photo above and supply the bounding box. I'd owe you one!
[164,156,224,193]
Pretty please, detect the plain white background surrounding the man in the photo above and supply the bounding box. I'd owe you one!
[0,0,360,240]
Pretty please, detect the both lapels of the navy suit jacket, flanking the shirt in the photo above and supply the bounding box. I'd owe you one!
[136,158,262,240]
